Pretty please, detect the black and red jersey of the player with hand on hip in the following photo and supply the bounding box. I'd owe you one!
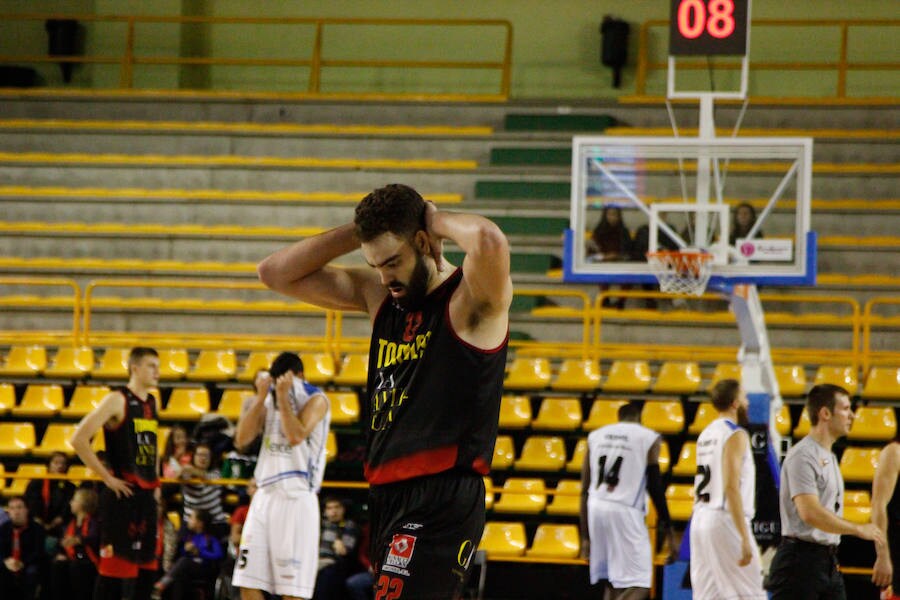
[103,386,159,489]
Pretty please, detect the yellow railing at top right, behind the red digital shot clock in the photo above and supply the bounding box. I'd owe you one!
[635,19,900,99]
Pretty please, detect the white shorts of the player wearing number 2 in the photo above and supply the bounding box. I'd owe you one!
[691,509,768,600]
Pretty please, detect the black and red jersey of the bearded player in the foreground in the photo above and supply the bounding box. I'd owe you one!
[363,269,509,484]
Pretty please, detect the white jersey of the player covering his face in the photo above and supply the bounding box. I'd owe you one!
[253,379,331,493]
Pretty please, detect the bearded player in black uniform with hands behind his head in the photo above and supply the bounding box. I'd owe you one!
[259,184,512,600]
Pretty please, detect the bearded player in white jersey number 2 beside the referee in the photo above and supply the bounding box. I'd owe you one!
[690,379,767,600]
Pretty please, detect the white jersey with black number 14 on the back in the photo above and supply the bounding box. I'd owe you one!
[588,422,659,511]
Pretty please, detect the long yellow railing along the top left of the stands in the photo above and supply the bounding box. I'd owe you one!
[0,14,513,101]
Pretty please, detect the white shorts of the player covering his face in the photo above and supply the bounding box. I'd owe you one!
[231,488,320,598]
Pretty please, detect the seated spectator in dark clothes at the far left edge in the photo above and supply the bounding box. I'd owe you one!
[0,496,46,600]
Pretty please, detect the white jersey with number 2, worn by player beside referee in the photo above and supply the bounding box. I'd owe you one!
[694,418,756,519]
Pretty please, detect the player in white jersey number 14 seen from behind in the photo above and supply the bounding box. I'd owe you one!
[581,402,675,600]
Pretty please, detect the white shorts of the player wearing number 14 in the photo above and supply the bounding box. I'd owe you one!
[588,498,653,589]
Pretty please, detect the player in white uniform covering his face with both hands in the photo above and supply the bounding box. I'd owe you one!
[232,352,330,600]
